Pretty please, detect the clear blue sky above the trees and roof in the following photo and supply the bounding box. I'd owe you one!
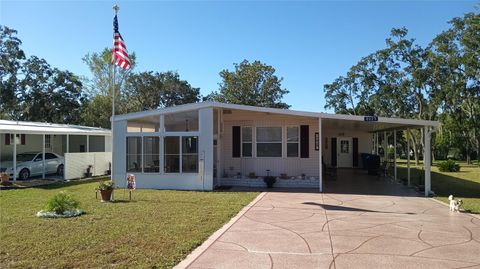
[0,0,479,111]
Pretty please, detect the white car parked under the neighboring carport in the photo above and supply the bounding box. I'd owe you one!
[0,152,64,180]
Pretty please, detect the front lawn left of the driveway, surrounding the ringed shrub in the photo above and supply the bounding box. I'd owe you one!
[0,178,258,268]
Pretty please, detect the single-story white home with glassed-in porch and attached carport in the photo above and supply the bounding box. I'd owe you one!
[113,102,439,196]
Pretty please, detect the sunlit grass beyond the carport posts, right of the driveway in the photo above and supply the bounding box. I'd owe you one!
[398,160,480,214]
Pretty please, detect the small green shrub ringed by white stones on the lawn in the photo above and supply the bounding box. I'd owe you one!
[36,191,84,218]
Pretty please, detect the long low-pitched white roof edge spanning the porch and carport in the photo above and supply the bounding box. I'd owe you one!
[114,102,440,132]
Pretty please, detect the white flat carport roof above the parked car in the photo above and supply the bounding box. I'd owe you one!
[0,120,111,136]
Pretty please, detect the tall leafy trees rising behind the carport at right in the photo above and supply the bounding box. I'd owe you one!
[324,13,480,161]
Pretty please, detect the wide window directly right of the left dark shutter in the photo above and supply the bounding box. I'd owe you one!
[256,127,282,157]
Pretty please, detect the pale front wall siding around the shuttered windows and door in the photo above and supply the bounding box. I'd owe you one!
[219,111,372,177]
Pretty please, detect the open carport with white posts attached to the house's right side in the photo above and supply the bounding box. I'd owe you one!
[319,113,439,196]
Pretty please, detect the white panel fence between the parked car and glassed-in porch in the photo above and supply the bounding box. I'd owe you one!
[64,152,112,179]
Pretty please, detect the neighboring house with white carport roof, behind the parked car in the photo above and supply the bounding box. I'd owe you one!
[0,120,111,180]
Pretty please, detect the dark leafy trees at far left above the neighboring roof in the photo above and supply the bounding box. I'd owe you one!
[0,26,84,123]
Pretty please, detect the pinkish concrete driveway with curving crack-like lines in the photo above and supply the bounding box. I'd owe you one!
[179,171,480,269]
